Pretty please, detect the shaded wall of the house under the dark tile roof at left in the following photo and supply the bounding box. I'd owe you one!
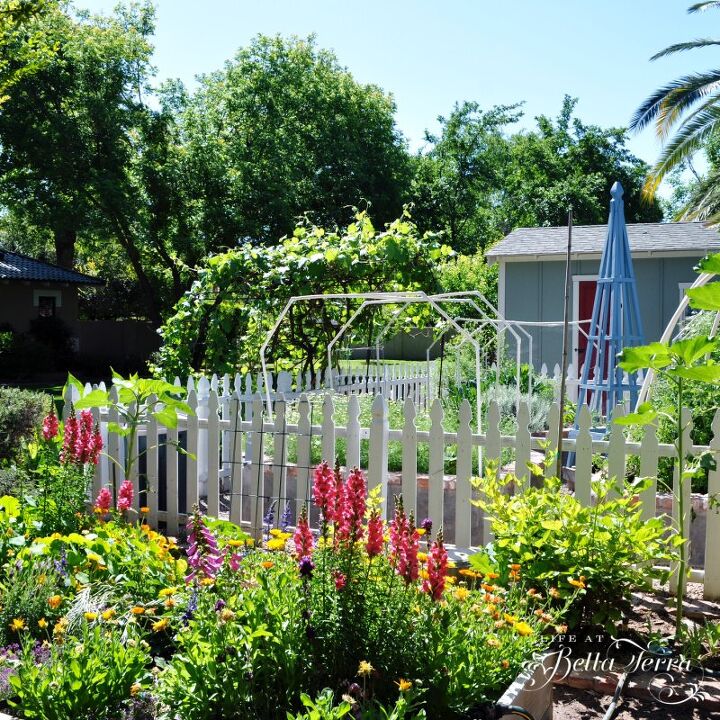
[0,282,78,332]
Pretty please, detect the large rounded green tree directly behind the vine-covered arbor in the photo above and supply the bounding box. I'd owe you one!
[174,36,408,250]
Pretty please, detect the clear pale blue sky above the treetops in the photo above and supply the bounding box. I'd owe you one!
[83,0,720,162]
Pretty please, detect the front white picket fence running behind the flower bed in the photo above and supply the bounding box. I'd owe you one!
[66,380,720,598]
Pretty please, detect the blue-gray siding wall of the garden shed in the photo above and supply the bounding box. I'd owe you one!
[501,255,702,370]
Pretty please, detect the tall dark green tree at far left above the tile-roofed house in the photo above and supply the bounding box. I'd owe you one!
[0,4,167,321]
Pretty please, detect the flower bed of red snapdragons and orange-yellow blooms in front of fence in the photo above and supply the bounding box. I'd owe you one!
[0,414,582,720]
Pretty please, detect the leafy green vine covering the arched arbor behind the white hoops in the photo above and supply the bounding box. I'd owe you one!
[155,212,452,377]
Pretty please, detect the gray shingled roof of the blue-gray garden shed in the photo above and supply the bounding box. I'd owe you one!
[486,222,720,260]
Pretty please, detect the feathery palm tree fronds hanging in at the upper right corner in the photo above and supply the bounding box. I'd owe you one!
[630,2,720,200]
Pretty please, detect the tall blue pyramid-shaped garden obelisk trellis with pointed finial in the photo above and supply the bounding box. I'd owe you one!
[576,182,644,417]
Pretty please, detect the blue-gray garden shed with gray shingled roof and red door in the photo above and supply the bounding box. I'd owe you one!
[486,222,720,369]
